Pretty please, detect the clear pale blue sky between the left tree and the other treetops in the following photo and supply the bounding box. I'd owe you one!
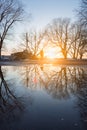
[3,0,80,52]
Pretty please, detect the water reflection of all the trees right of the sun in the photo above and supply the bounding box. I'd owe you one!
[46,67,87,125]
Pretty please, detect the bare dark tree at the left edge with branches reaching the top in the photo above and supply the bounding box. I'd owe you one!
[0,0,23,58]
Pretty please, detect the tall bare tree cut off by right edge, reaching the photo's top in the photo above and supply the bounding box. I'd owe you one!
[75,0,87,59]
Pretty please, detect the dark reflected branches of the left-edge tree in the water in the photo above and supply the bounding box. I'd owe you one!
[0,66,22,112]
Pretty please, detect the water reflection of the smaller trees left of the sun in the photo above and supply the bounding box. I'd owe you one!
[19,65,49,89]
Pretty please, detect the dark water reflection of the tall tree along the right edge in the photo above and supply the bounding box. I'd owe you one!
[73,69,87,125]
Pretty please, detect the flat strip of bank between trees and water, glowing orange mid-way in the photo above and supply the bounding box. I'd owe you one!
[0,59,87,66]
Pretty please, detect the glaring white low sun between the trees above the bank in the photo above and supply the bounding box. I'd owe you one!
[45,47,57,58]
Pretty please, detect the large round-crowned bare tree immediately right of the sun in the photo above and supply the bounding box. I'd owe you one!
[47,18,71,58]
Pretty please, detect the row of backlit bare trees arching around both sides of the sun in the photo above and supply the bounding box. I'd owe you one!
[17,18,87,59]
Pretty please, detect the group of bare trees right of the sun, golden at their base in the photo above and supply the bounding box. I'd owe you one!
[46,18,87,59]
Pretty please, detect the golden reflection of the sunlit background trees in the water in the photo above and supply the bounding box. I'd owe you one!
[20,65,86,99]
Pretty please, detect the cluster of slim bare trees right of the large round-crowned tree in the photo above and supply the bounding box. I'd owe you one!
[70,22,87,59]
